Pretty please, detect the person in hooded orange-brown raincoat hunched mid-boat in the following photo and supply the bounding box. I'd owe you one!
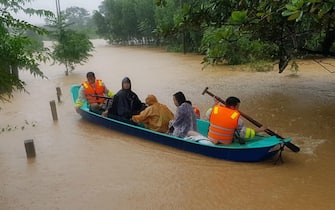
[131,94,174,133]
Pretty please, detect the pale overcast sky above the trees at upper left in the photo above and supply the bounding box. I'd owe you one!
[17,0,103,24]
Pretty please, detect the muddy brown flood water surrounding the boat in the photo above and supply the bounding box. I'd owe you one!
[0,40,335,210]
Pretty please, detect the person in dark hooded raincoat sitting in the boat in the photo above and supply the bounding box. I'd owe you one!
[102,77,146,124]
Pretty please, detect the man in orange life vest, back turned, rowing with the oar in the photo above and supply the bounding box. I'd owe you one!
[207,96,266,144]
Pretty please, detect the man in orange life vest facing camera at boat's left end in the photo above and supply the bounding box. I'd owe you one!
[75,72,113,114]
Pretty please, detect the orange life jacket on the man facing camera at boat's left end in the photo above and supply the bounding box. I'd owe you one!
[82,80,105,104]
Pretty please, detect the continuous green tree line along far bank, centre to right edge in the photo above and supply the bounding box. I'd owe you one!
[93,0,335,72]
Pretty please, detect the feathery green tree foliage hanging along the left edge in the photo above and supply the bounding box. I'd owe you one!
[0,0,53,101]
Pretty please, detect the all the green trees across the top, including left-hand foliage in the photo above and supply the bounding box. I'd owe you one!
[0,0,335,104]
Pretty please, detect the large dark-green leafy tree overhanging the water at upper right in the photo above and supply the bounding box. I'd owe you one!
[171,0,335,73]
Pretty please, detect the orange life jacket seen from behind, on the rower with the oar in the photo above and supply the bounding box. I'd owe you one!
[208,105,240,144]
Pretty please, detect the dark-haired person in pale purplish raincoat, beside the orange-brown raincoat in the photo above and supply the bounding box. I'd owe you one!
[169,91,198,138]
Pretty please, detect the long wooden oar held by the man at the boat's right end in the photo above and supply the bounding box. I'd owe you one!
[202,87,300,152]
